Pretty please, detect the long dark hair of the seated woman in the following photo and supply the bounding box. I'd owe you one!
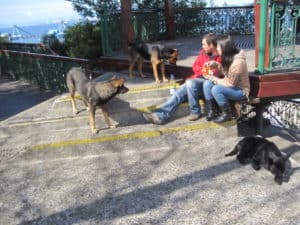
[217,35,240,72]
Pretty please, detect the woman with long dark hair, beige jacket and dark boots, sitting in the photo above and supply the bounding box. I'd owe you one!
[203,36,250,123]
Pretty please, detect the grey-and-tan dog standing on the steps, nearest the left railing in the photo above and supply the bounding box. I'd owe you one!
[67,67,128,134]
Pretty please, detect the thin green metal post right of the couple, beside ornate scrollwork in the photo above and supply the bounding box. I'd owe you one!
[257,0,268,74]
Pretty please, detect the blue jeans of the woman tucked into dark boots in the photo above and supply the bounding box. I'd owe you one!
[203,80,247,107]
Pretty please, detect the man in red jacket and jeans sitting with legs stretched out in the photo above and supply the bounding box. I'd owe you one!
[143,33,220,124]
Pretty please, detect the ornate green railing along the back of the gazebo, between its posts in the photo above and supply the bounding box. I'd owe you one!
[101,6,254,55]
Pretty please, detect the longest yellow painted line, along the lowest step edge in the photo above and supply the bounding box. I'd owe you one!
[31,120,236,150]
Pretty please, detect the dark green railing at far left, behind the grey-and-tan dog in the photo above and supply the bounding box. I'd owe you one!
[0,50,87,93]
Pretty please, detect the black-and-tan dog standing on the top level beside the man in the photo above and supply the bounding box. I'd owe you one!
[128,42,178,83]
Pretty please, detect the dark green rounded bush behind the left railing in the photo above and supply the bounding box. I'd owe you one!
[65,23,102,60]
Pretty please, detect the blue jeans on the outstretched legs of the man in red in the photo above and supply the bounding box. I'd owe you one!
[154,78,204,122]
